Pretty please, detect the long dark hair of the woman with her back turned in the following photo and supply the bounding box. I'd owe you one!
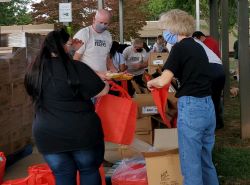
[24,29,77,104]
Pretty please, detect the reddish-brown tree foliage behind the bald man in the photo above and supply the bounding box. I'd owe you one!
[32,0,148,40]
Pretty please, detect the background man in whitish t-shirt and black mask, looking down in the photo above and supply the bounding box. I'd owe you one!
[123,38,148,96]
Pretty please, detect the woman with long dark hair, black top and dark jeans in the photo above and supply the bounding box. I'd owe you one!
[25,29,109,185]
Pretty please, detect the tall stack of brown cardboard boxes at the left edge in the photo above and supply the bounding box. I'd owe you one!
[0,48,33,155]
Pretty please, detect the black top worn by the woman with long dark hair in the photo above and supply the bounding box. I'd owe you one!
[33,58,105,153]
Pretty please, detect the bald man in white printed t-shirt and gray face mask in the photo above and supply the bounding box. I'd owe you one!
[73,9,112,76]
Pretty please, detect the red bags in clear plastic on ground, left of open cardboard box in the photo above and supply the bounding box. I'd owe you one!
[111,159,148,185]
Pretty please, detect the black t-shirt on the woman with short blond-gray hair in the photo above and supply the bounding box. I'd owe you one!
[163,38,212,98]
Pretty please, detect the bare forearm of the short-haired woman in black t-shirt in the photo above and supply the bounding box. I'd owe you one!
[147,70,174,90]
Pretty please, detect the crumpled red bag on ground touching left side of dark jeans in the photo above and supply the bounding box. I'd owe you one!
[28,164,56,185]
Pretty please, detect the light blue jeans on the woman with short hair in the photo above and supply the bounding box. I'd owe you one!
[177,96,219,185]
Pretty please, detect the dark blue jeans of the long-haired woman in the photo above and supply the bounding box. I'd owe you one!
[43,142,104,185]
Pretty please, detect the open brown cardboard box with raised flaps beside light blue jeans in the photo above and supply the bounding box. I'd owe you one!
[112,128,183,185]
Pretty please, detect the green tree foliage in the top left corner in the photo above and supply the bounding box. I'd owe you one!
[0,0,32,26]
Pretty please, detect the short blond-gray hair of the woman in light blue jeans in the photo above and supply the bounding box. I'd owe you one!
[159,9,195,36]
